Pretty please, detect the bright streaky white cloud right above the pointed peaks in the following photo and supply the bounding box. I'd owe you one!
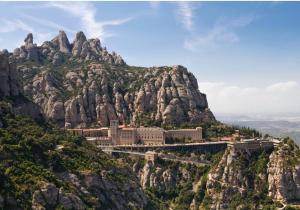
[50,2,133,39]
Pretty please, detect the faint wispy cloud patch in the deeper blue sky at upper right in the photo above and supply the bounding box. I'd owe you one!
[184,16,255,50]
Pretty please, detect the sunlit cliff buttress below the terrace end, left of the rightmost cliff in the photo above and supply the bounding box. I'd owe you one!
[206,149,266,209]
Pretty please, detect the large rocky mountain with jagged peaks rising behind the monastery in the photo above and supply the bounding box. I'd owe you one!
[6,31,215,128]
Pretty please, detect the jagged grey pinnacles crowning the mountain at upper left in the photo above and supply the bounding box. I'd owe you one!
[12,31,125,66]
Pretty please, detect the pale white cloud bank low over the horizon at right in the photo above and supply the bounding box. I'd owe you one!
[199,81,300,114]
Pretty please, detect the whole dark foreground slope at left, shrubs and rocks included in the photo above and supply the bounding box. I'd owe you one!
[0,53,149,210]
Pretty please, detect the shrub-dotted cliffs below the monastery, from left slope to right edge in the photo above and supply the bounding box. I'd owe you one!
[117,138,300,210]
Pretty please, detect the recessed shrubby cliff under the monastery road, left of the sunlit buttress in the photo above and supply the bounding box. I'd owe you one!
[130,154,209,210]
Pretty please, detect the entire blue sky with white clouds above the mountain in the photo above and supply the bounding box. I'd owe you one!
[0,2,300,114]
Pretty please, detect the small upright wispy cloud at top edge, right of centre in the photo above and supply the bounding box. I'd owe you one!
[176,1,194,31]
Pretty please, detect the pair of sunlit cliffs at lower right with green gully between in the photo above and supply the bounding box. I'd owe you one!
[206,140,300,209]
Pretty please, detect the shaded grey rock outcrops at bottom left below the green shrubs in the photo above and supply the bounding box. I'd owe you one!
[32,170,147,210]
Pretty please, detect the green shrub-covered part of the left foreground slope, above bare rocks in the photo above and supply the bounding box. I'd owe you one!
[0,103,132,209]
